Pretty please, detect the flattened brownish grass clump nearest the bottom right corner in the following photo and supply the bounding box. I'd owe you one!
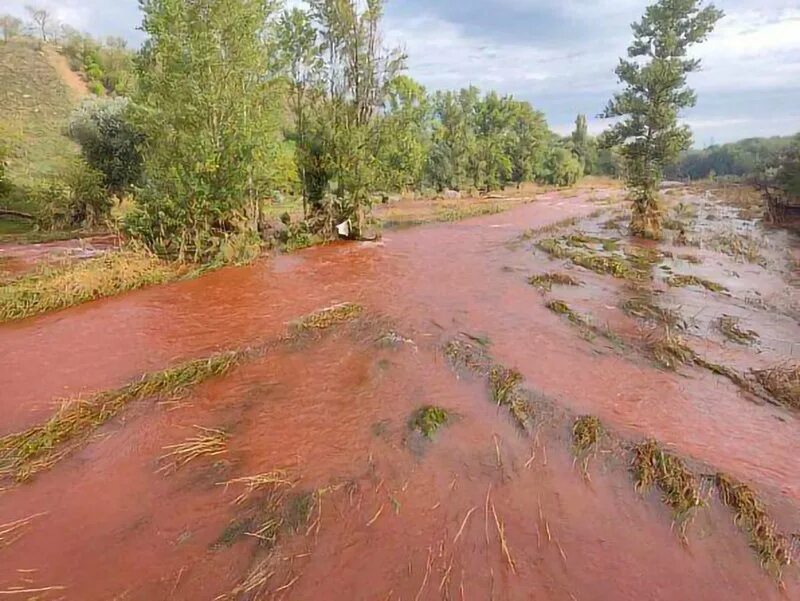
[715,474,792,580]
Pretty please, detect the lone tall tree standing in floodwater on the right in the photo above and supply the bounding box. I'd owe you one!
[601,0,723,238]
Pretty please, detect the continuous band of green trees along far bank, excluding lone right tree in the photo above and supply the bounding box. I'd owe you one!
[5,0,619,261]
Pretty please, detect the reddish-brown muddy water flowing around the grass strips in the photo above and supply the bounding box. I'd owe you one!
[0,198,800,600]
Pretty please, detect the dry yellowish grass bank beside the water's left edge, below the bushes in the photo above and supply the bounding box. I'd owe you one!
[0,251,180,322]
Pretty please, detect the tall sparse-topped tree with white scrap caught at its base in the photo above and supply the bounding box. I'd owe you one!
[299,0,405,236]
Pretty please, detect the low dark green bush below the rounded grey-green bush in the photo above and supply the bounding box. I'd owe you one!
[31,160,113,230]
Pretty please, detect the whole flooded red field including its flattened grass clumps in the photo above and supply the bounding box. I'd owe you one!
[0,189,800,601]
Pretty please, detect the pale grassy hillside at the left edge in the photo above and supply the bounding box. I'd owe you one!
[0,39,79,210]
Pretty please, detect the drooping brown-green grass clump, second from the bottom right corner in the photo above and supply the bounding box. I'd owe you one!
[633,440,703,534]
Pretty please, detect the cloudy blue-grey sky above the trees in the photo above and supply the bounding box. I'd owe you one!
[3,0,800,146]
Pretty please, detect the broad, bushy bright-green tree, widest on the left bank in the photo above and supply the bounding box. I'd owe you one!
[127,0,280,261]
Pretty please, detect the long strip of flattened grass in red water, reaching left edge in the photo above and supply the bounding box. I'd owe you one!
[0,352,244,481]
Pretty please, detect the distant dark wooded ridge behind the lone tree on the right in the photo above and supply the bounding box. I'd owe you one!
[665,136,796,179]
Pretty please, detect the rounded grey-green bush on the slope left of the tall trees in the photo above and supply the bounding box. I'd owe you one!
[69,98,144,193]
